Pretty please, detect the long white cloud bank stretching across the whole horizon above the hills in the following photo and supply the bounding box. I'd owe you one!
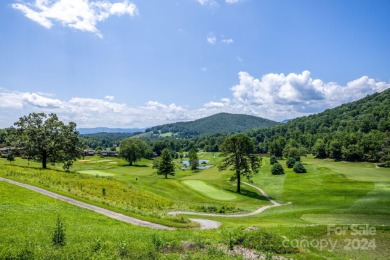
[0,71,390,127]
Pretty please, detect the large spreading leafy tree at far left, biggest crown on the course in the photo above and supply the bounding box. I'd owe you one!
[7,113,83,170]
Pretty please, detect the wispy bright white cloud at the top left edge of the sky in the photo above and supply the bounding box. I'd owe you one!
[12,0,137,37]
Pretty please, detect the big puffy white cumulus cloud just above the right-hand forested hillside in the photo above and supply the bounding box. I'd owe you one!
[231,71,390,120]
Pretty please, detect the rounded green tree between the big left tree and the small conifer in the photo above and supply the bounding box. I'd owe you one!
[119,138,148,166]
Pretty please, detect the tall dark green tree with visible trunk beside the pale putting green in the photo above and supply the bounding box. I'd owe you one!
[218,133,261,193]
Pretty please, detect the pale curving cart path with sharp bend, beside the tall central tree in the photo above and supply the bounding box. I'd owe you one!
[168,182,291,218]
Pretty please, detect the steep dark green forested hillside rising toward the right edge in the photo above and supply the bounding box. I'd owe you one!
[250,90,390,161]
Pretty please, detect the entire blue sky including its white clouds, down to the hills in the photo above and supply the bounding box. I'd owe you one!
[0,0,390,127]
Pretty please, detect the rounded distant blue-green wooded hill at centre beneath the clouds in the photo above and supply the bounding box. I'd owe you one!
[145,113,278,136]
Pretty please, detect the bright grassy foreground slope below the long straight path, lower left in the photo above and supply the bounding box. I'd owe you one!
[0,182,235,259]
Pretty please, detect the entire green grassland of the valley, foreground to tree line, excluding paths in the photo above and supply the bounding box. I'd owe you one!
[0,153,390,259]
